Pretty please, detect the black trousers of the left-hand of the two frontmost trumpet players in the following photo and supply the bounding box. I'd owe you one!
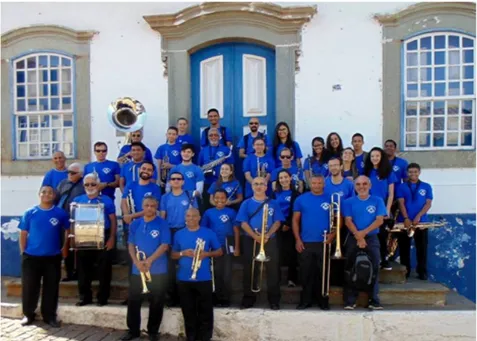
[127,274,167,335]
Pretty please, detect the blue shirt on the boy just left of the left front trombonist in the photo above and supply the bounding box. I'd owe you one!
[200,207,237,246]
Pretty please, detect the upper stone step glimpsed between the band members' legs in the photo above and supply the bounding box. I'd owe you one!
[61,260,406,287]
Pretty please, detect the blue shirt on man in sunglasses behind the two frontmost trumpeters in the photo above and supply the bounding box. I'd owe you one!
[161,191,198,228]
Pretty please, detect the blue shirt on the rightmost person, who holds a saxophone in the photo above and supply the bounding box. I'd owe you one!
[397,181,434,222]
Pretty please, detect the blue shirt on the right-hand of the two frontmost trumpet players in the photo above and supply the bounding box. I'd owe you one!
[172,227,221,282]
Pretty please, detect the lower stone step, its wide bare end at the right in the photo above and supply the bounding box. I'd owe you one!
[5,278,449,306]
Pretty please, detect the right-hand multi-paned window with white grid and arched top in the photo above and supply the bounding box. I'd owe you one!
[402,32,475,150]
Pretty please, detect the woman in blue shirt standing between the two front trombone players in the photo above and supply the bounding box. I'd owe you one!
[273,169,300,287]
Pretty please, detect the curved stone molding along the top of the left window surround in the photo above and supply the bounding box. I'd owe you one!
[2,25,98,47]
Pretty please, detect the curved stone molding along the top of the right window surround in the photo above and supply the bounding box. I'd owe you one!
[374,2,475,26]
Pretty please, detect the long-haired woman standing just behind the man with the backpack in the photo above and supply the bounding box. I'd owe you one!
[364,147,396,270]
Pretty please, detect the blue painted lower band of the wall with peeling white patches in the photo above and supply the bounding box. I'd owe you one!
[1,214,476,302]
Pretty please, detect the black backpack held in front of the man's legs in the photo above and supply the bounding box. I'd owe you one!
[348,250,377,292]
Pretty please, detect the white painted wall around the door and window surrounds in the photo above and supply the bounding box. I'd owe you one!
[1,2,475,216]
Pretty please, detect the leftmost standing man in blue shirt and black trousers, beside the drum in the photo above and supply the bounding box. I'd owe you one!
[20,186,70,328]
